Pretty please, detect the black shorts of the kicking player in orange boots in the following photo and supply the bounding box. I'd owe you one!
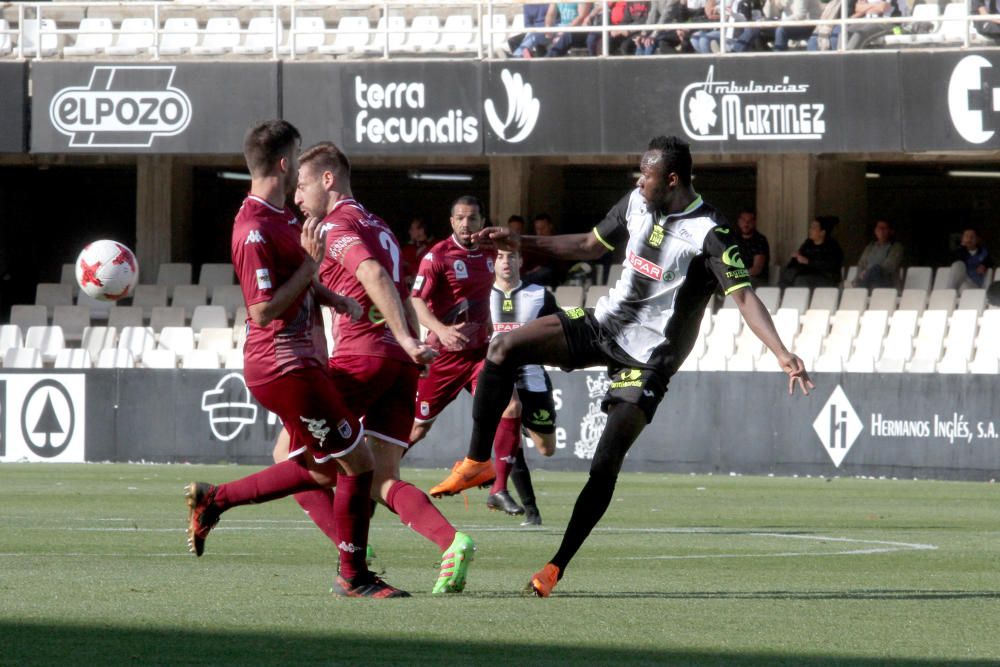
[558,308,671,423]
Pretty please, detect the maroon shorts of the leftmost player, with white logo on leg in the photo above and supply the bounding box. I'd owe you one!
[250,366,365,463]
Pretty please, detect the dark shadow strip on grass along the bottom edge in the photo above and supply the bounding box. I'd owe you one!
[0,620,995,667]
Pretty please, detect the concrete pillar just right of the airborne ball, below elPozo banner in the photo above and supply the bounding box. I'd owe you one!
[135,155,192,282]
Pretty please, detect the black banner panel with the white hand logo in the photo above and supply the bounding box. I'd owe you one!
[482,59,600,155]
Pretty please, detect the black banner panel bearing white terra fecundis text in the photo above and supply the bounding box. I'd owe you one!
[282,61,483,155]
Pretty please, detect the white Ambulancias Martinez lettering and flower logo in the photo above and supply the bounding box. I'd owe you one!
[680,65,826,141]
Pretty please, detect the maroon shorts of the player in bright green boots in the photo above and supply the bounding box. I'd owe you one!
[329,355,420,447]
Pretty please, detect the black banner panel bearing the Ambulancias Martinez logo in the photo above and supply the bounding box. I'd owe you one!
[600,53,901,154]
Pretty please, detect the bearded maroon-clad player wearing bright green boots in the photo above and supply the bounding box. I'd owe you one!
[275,142,475,593]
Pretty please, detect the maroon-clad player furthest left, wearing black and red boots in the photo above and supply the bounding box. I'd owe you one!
[186,120,409,598]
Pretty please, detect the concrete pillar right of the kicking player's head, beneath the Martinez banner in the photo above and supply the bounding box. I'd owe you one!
[757,154,816,266]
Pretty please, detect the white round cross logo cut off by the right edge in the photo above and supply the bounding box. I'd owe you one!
[948,56,1000,144]
